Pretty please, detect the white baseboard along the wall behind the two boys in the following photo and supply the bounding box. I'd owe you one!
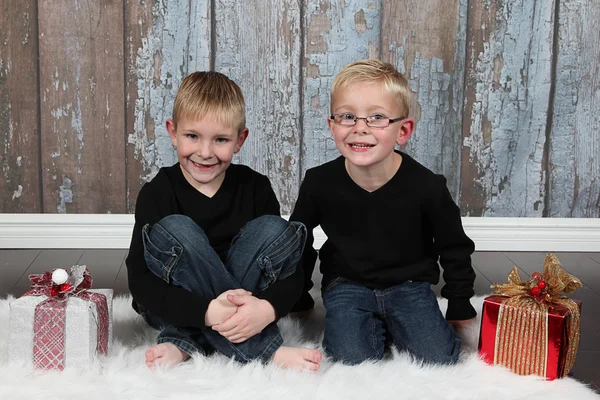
[0,214,600,252]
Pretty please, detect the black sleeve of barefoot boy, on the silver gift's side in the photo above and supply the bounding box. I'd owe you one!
[125,185,211,328]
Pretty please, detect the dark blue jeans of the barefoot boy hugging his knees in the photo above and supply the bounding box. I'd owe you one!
[138,215,306,363]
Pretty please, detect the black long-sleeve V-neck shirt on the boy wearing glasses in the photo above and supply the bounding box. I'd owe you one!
[290,153,477,320]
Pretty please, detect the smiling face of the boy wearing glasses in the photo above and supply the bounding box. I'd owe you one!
[328,82,414,168]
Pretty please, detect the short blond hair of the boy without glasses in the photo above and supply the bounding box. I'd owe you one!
[173,71,246,133]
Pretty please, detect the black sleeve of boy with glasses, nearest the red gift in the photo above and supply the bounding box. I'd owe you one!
[429,175,477,320]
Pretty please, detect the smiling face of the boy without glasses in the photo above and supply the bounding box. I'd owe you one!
[167,117,248,196]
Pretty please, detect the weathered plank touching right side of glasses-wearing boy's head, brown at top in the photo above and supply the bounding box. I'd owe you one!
[381,0,467,199]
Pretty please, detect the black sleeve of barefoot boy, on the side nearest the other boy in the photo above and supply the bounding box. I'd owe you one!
[256,177,303,320]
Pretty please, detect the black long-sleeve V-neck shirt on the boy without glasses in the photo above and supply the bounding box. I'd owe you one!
[126,164,303,328]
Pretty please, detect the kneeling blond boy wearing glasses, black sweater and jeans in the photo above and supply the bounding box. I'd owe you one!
[290,60,476,364]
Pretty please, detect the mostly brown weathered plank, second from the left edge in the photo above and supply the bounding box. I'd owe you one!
[38,0,125,213]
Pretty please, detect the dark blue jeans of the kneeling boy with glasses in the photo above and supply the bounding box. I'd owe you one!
[323,278,460,364]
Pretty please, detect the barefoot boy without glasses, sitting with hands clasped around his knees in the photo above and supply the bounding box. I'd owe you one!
[126,72,321,371]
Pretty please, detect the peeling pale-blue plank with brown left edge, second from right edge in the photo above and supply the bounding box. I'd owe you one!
[460,0,555,217]
